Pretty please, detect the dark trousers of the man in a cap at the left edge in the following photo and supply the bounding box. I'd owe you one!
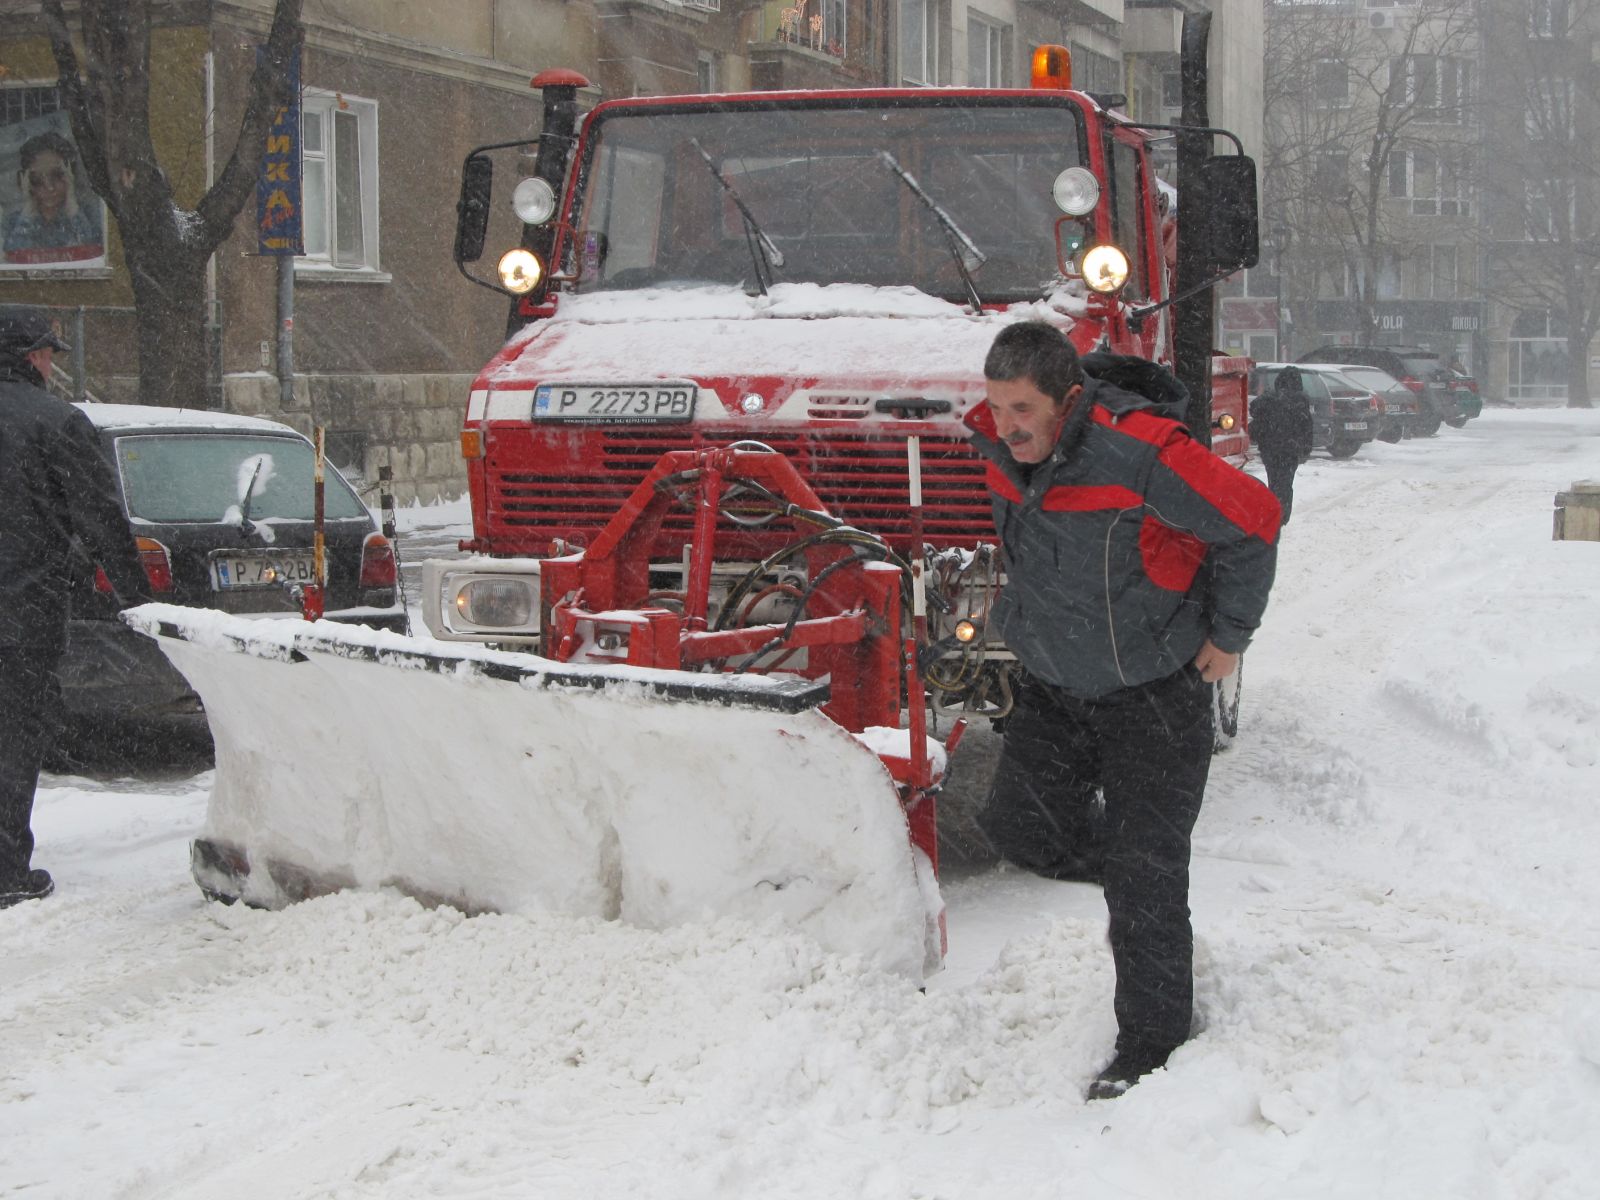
[0,645,61,888]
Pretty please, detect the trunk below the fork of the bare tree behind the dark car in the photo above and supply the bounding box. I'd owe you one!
[123,243,213,408]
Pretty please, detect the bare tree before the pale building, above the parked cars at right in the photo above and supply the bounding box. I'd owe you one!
[1266,0,1477,342]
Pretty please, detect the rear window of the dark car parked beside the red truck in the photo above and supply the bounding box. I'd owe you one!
[117,434,368,525]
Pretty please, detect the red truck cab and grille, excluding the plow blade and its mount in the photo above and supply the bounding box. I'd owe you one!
[426,27,1256,729]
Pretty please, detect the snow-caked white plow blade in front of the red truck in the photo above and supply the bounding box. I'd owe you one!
[126,605,939,978]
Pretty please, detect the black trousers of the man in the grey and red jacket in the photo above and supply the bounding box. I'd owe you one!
[981,666,1214,1064]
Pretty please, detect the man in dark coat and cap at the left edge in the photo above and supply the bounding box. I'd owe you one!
[0,306,149,909]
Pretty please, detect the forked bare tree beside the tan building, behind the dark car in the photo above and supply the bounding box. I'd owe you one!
[43,0,304,408]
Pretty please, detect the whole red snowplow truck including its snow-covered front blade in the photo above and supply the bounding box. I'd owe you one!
[130,21,1256,976]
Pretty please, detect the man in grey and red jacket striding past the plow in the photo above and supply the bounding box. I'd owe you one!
[966,322,1278,1099]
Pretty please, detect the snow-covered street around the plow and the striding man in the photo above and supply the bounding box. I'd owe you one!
[0,408,1600,1200]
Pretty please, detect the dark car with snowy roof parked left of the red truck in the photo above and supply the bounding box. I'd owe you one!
[61,405,406,742]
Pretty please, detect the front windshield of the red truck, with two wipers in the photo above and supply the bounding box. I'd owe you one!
[568,94,1083,302]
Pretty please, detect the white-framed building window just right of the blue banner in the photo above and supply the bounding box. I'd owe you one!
[299,88,378,270]
